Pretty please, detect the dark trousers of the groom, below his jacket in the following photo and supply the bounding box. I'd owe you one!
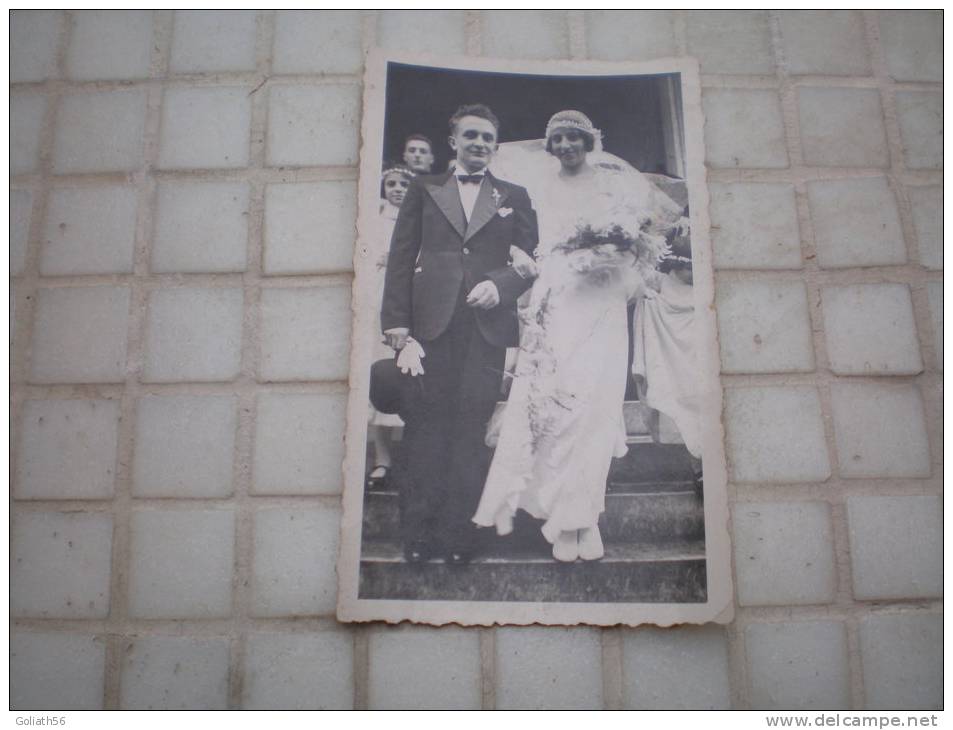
[393,287,506,550]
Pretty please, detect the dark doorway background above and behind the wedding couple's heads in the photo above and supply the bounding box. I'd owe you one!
[384,63,678,174]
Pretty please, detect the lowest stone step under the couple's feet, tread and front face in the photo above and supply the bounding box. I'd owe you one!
[358,541,707,603]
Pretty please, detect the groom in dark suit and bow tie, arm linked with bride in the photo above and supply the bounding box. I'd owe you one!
[381,104,537,565]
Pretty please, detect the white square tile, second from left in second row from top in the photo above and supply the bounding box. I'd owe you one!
[53,89,146,173]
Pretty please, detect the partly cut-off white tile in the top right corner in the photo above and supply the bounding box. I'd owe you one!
[877,9,943,81]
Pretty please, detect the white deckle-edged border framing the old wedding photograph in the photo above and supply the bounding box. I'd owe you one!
[337,49,734,626]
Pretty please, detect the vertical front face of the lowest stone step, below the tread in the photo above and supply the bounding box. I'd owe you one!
[359,559,707,603]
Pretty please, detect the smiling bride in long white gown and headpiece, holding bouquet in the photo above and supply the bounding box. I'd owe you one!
[473,110,680,562]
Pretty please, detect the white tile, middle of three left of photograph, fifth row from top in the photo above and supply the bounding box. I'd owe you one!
[132,395,238,497]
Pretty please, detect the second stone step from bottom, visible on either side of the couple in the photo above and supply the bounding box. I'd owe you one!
[363,485,705,544]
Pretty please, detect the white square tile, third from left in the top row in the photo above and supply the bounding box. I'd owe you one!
[169,10,258,73]
